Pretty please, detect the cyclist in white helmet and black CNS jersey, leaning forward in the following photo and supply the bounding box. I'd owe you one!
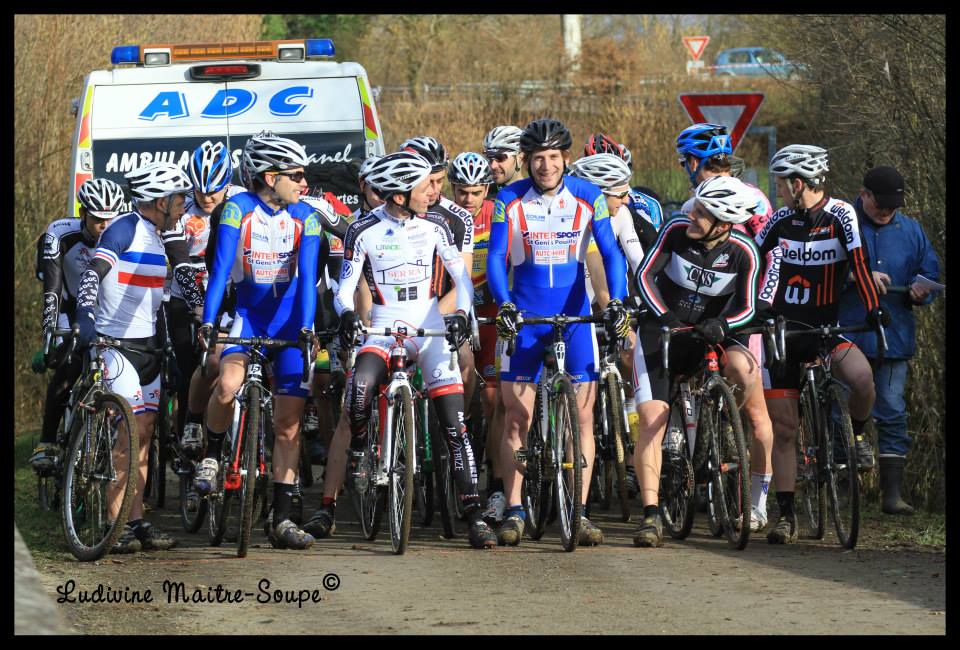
[633,177,760,546]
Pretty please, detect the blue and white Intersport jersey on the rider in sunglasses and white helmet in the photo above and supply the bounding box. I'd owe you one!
[203,192,320,334]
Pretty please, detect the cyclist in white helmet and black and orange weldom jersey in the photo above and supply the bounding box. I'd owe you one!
[756,144,889,544]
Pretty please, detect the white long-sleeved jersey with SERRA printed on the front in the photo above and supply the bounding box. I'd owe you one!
[334,206,473,328]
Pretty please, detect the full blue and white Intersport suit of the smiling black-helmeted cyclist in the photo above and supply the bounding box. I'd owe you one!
[487,176,627,383]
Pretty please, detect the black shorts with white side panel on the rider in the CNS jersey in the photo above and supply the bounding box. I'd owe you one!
[633,319,750,405]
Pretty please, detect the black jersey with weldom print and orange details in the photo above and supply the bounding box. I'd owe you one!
[756,197,880,325]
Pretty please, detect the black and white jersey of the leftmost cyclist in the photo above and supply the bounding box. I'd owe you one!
[37,218,97,329]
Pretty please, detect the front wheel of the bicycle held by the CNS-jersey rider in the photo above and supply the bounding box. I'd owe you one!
[697,377,750,550]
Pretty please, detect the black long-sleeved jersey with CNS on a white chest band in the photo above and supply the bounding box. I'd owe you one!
[637,219,760,329]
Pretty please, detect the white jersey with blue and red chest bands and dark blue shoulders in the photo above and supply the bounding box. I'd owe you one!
[89,211,167,338]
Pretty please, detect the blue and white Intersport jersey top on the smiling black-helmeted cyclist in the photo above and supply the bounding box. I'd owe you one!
[487,176,627,315]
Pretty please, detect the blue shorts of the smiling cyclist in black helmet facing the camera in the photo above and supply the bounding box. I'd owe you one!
[500,323,600,384]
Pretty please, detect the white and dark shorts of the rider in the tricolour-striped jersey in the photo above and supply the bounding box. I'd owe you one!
[99,338,160,415]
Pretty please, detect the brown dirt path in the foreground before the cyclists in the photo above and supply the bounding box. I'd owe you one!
[28,470,946,634]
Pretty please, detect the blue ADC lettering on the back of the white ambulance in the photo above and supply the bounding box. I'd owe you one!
[138,86,313,122]
